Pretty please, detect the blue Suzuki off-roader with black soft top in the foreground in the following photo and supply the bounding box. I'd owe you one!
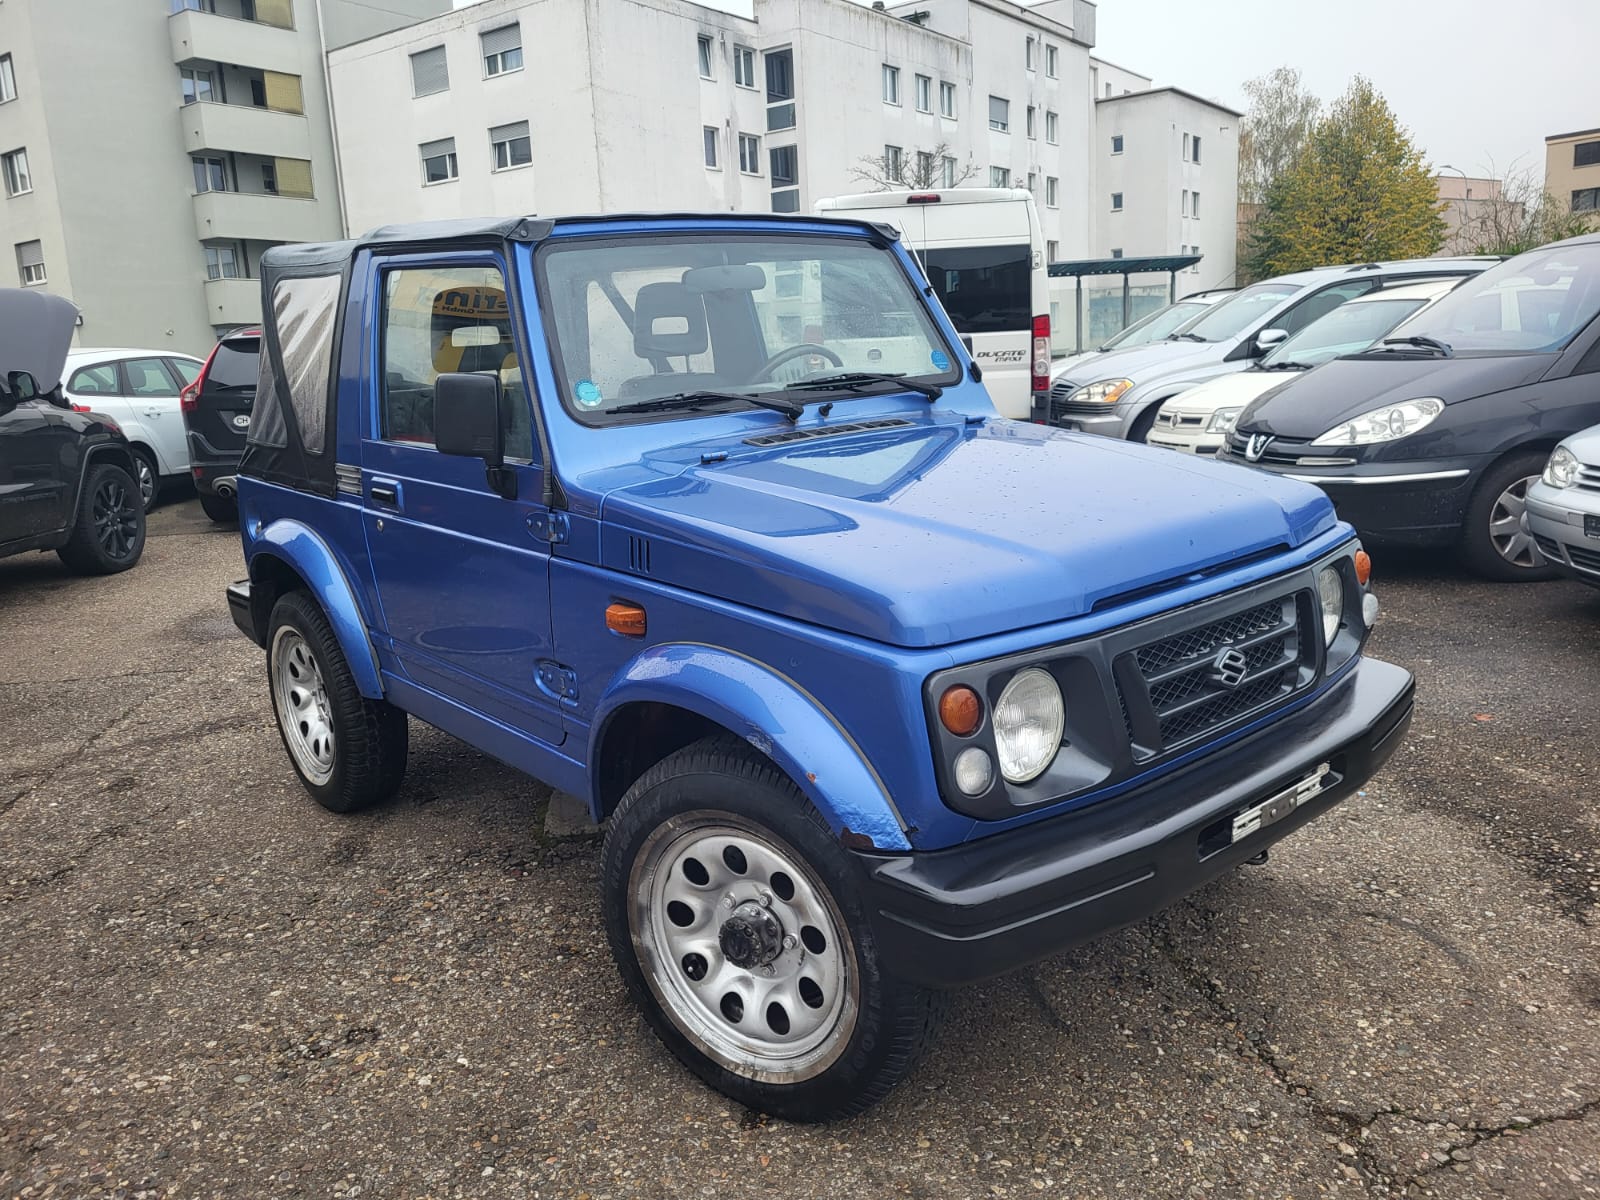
[227,213,1413,1120]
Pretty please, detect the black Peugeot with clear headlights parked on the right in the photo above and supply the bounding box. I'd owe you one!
[1222,234,1600,579]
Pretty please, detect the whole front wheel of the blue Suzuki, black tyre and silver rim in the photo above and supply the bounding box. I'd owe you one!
[603,738,942,1120]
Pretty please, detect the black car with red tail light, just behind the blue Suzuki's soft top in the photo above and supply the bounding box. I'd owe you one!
[179,330,261,522]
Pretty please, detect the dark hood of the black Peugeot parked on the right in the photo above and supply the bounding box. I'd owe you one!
[1238,354,1555,440]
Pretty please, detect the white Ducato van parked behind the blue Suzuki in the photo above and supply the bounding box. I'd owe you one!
[816,187,1050,421]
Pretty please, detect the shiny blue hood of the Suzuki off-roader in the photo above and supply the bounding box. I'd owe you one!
[602,418,1334,646]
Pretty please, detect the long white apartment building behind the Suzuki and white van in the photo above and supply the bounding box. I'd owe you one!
[328,0,1238,344]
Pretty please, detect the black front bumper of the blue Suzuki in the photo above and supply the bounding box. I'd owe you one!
[861,659,1413,987]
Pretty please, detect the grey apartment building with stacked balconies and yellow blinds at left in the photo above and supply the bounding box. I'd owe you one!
[0,0,450,355]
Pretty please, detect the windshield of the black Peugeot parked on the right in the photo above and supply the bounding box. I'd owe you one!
[1390,243,1600,354]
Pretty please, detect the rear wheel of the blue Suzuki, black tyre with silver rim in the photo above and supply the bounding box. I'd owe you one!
[267,592,408,813]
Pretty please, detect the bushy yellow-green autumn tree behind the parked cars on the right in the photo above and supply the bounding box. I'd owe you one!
[1243,77,1445,278]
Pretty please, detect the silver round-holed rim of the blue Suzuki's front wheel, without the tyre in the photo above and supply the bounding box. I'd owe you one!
[629,811,859,1083]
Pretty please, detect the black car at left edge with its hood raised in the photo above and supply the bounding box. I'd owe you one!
[0,288,144,574]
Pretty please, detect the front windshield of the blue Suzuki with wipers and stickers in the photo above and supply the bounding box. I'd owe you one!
[538,234,962,422]
